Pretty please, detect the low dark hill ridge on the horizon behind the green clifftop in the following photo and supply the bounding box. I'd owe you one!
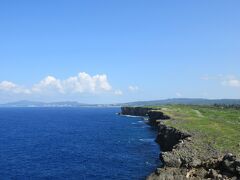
[118,98,240,106]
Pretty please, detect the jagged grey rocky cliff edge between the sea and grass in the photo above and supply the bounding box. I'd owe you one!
[121,107,240,180]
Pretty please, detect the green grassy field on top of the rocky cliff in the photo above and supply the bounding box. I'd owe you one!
[150,105,240,156]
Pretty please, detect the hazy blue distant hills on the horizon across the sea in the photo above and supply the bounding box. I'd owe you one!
[0,101,99,107]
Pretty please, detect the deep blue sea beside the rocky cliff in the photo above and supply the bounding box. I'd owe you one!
[0,108,160,180]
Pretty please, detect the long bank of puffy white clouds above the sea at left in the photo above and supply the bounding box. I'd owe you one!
[0,72,116,95]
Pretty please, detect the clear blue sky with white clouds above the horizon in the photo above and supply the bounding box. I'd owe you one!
[0,0,240,103]
